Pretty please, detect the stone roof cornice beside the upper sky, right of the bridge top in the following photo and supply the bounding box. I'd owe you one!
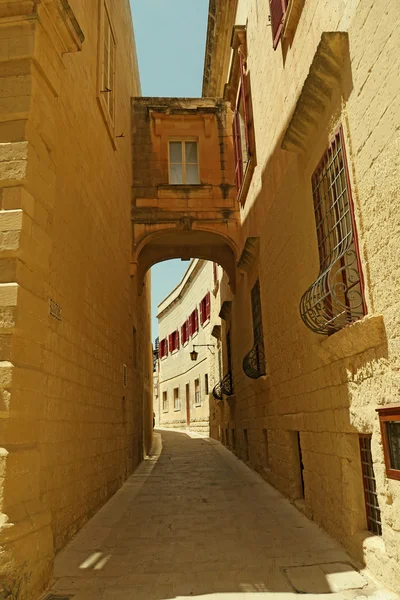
[202,0,238,97]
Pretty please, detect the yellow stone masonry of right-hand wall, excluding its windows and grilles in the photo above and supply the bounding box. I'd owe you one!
[212,0,400,589]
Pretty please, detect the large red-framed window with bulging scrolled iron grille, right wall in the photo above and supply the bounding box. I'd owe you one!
[300,128,366,335]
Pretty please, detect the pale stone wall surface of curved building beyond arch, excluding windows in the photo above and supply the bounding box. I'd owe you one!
[155,259,222,434]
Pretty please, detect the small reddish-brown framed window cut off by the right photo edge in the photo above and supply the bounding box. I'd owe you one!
[377,404,400,479]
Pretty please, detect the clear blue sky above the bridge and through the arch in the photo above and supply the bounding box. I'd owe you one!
[131,0,209,339]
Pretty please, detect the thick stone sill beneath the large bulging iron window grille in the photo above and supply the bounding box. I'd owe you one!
[313,315,387,363]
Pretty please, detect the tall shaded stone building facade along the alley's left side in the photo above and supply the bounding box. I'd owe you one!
[0,0,152,600]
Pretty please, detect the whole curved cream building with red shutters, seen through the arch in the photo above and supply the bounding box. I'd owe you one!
[155,259,222,435]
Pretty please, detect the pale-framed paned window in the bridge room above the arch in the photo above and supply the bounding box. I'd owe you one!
[169,140,200,185]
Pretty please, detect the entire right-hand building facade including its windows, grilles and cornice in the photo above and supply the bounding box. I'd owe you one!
[203,0,400,590]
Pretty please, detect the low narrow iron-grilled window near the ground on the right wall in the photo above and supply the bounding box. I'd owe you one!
[360,435,382,535]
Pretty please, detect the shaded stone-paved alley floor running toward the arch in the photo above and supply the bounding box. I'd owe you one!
[45,430,396,600]
